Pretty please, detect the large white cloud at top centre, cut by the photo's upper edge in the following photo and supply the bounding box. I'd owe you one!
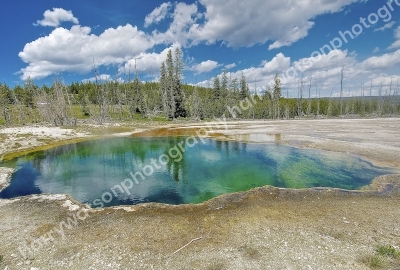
[169,0,362,49]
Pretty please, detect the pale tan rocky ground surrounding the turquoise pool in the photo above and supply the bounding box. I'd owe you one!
[0,118,400,269]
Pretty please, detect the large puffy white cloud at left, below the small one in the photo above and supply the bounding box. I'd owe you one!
[18,24,154,80]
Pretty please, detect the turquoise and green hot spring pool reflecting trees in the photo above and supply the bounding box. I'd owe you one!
[0,137,395,207]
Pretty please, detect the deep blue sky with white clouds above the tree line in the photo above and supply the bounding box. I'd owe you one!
[0,0,400,97]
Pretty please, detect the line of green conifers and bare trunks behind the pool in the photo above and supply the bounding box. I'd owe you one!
[0,48,400,126]
